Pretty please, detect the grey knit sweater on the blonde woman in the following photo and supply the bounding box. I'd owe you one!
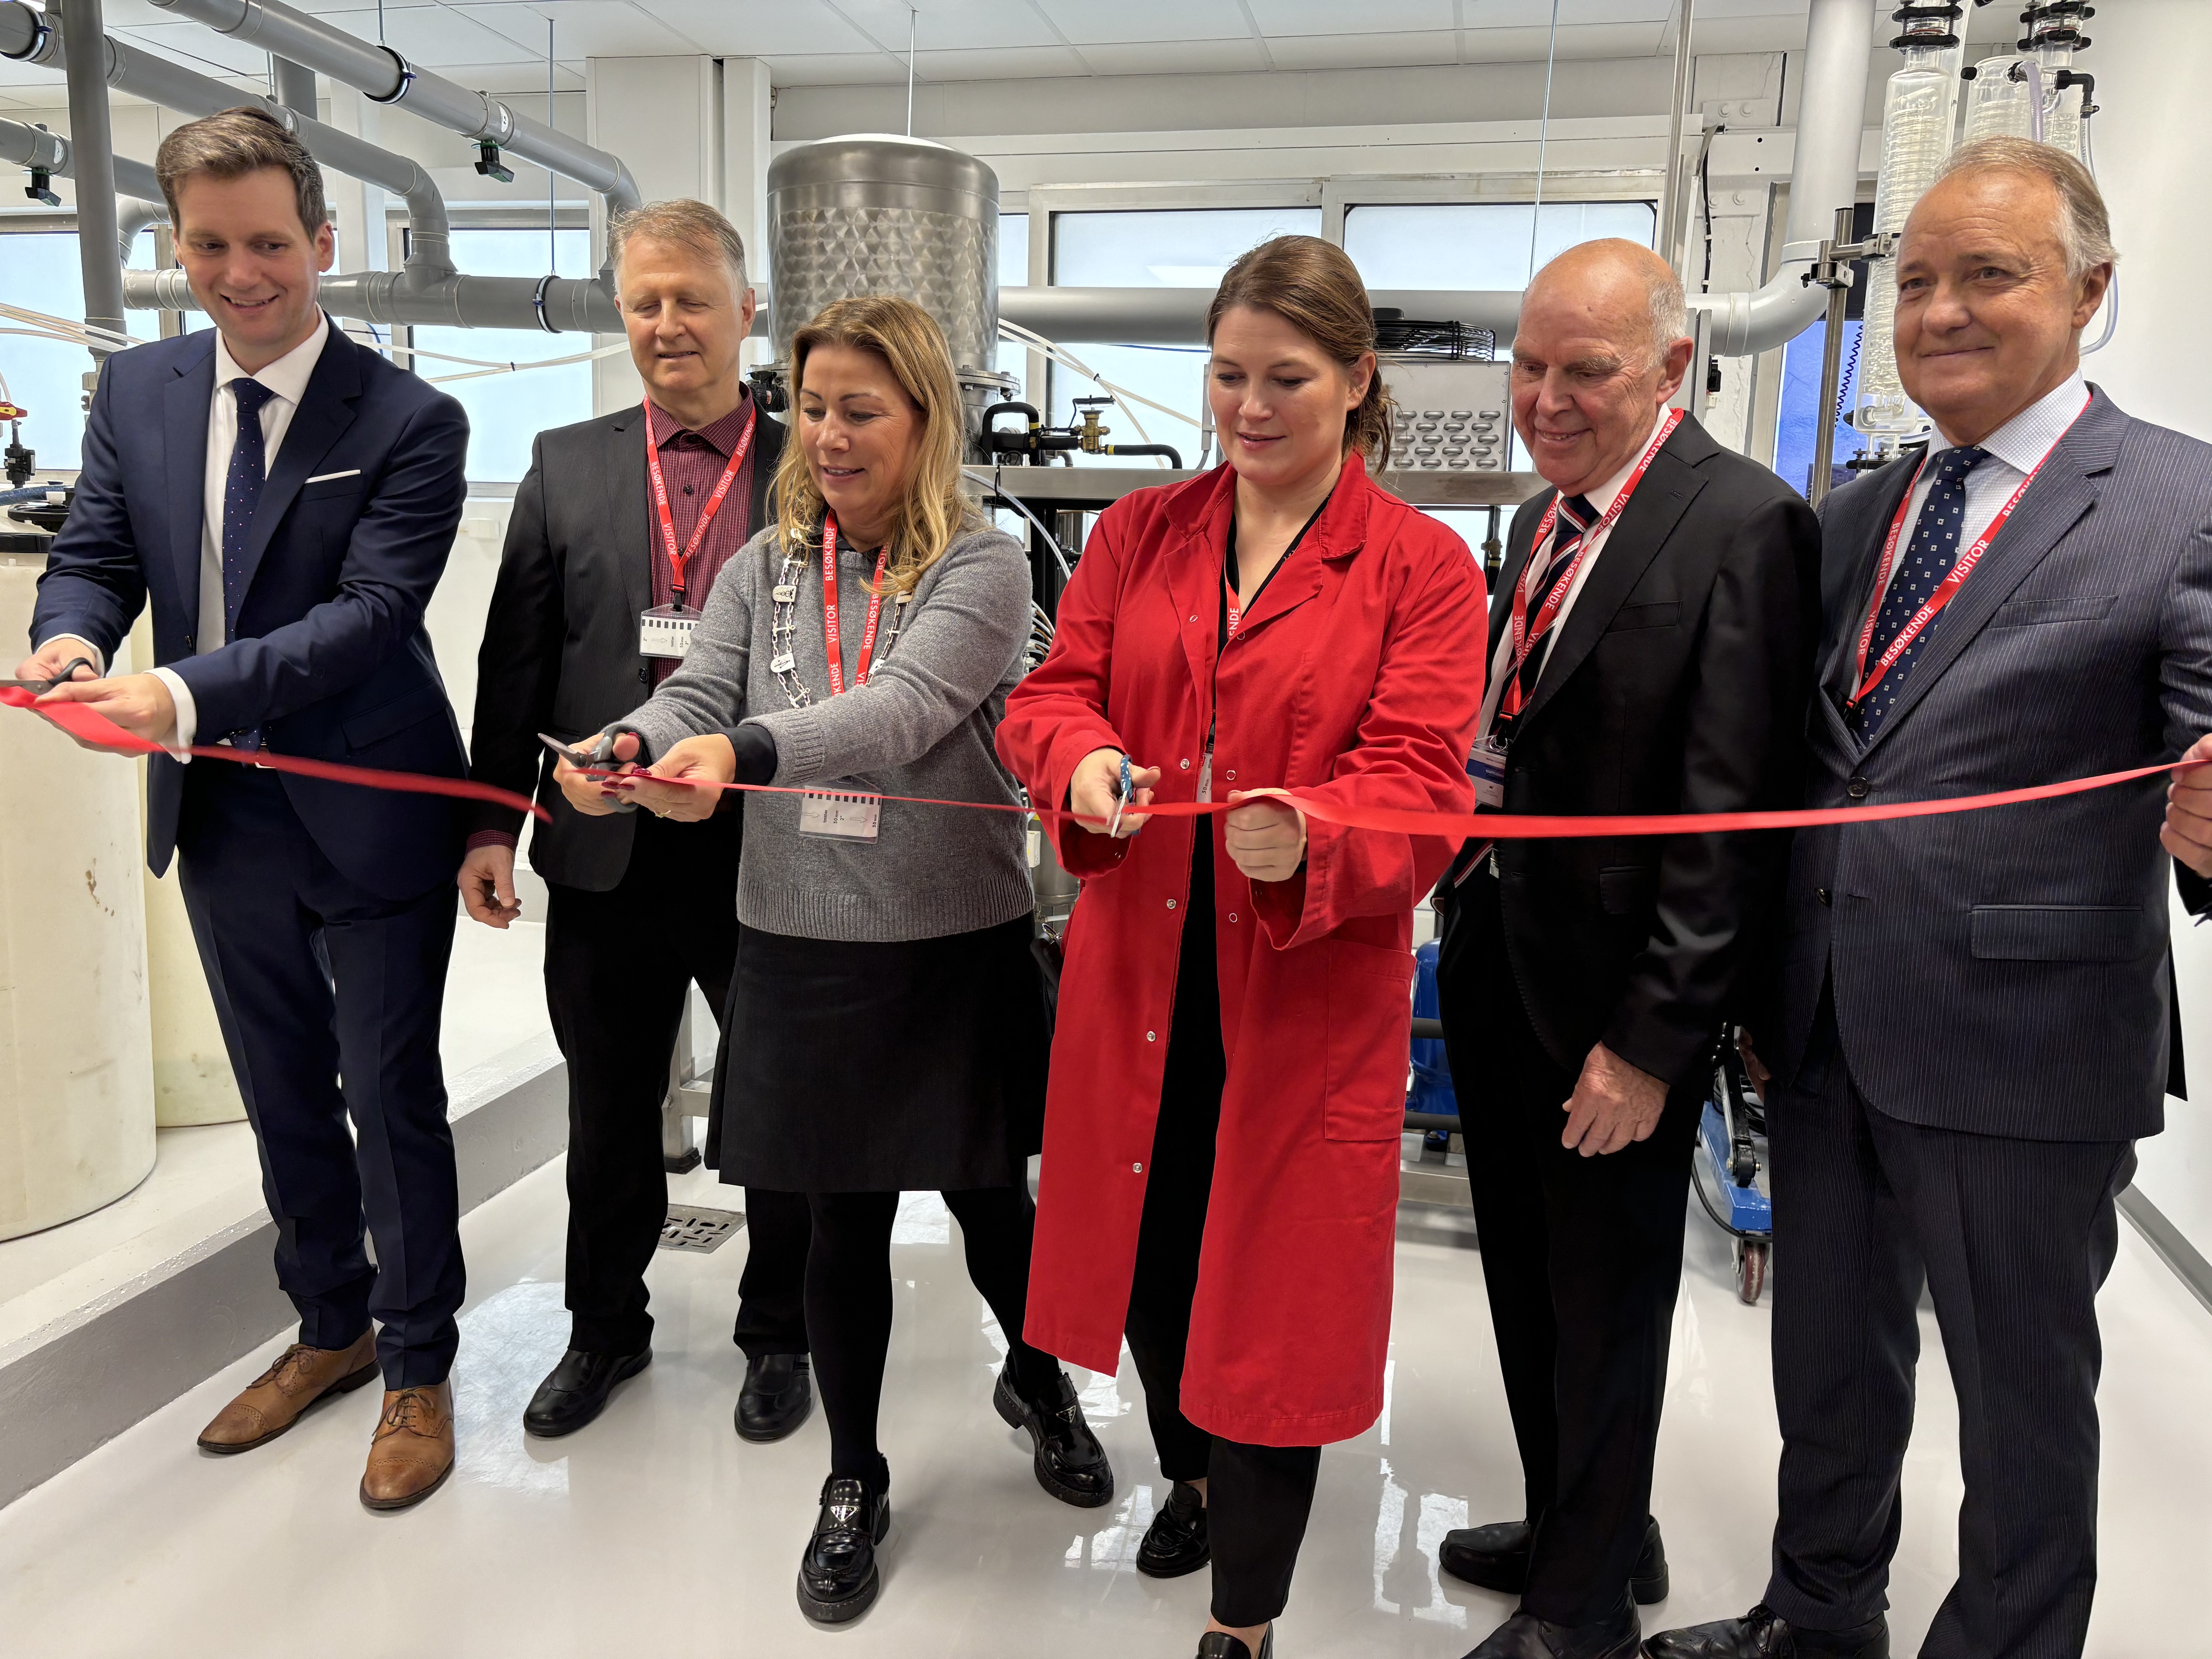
[608,524,1035,940]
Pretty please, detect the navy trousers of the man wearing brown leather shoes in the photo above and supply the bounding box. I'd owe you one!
[177,761,465,1389]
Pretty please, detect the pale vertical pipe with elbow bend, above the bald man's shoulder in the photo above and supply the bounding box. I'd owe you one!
[1690,0,1887,356]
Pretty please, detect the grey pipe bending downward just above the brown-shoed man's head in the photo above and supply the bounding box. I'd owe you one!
[0,0,453,281]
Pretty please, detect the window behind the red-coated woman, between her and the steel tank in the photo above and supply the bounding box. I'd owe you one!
[1046,208,1321,467]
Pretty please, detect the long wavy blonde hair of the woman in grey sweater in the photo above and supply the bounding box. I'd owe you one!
[774,294,982,593]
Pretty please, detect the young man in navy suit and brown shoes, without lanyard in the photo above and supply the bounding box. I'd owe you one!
[18,108,469,1509]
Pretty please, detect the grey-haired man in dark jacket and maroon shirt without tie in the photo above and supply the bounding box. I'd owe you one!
[460,201,814,1440]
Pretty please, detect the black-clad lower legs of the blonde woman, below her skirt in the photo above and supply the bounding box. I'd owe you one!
[805,1183,1060,1491]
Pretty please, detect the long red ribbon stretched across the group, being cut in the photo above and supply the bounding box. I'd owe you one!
[13,686,2212,841]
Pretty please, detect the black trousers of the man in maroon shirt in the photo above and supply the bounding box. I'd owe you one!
[546,812,807,1358]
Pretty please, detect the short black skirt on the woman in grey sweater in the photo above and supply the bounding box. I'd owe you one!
[706,916,1051,1192]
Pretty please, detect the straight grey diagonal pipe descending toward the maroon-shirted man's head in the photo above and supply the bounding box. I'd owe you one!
[153,0,644,250]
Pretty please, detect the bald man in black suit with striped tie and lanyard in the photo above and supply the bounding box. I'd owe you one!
[1438,241,1818,1659]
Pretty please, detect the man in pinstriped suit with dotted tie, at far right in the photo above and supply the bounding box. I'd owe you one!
[1648,139,2212,1659]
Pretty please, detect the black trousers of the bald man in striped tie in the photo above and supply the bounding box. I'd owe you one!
[1438,869,1703,1624]
